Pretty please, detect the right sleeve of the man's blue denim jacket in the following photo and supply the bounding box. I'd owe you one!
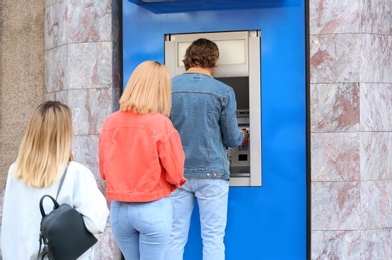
[219,89,244,148]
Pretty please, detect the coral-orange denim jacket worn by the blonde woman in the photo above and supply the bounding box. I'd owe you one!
[99,111,185,202]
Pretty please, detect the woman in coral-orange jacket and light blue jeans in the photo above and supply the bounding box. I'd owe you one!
[99,61,185,260]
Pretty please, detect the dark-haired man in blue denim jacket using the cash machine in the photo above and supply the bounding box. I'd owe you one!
[165,38,248,260]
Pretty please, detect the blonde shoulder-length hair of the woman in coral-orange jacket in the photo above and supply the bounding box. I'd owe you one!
[119,61,171,116]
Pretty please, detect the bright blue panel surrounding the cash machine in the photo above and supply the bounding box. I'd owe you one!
[122,0,309,260]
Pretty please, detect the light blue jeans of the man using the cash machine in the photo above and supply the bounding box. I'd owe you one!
[165,178,229,260]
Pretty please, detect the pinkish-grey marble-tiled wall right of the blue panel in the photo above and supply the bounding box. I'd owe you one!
[310,0,392,259]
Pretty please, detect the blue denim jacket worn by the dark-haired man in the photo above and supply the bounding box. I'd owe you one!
[170,68,244,179]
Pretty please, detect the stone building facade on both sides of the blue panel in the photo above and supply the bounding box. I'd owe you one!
[0,0,392,259]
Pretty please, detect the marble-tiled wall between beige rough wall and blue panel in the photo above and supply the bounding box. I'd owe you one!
[44,0,122,260]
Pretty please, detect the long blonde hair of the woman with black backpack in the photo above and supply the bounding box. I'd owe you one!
[13,101,73,188]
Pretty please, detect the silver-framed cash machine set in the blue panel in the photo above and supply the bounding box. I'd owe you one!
[165,30,262,186]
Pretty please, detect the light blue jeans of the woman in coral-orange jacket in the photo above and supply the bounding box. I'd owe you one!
[110,198,172,260]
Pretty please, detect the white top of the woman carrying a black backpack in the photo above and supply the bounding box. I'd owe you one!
[1,162,109,260]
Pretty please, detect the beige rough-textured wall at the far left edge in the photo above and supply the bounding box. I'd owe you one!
[0,0,45,189]
